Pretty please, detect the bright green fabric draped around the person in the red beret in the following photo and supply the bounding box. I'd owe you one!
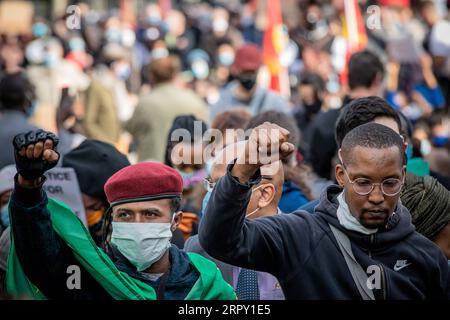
[6,199,236,300]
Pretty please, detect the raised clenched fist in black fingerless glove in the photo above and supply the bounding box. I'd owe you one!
[13,130,59,180]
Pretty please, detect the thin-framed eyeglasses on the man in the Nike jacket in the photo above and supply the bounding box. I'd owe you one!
[343,165,404,197]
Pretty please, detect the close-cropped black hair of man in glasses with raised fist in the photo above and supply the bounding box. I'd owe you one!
[341,122,405,165]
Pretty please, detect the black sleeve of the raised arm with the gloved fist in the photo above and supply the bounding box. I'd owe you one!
[10,180,110,300]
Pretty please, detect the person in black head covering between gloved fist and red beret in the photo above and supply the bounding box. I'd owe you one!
[62,139,130,245]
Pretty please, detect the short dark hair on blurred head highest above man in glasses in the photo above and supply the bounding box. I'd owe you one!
[348,50,384,90]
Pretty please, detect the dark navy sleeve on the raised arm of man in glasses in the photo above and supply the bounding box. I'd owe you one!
[199,165,308,277]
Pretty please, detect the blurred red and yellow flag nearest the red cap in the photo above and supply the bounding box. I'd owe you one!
[263,0,290,96]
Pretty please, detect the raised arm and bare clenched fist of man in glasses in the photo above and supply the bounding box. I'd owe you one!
[199,123,295,275]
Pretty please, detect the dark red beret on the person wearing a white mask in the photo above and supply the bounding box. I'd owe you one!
[105,162,183,207]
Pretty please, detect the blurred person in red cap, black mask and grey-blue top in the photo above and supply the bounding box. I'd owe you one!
[209,44,290,123]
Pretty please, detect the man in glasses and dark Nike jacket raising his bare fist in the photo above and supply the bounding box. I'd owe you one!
[199,123,450,300]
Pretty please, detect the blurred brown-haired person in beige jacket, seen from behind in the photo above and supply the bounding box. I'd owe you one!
[125,56,208,162]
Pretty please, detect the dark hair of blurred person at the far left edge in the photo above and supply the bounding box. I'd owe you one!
[0,72,35,111]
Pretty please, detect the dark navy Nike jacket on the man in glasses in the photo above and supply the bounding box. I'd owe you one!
[199,166,450,299]
